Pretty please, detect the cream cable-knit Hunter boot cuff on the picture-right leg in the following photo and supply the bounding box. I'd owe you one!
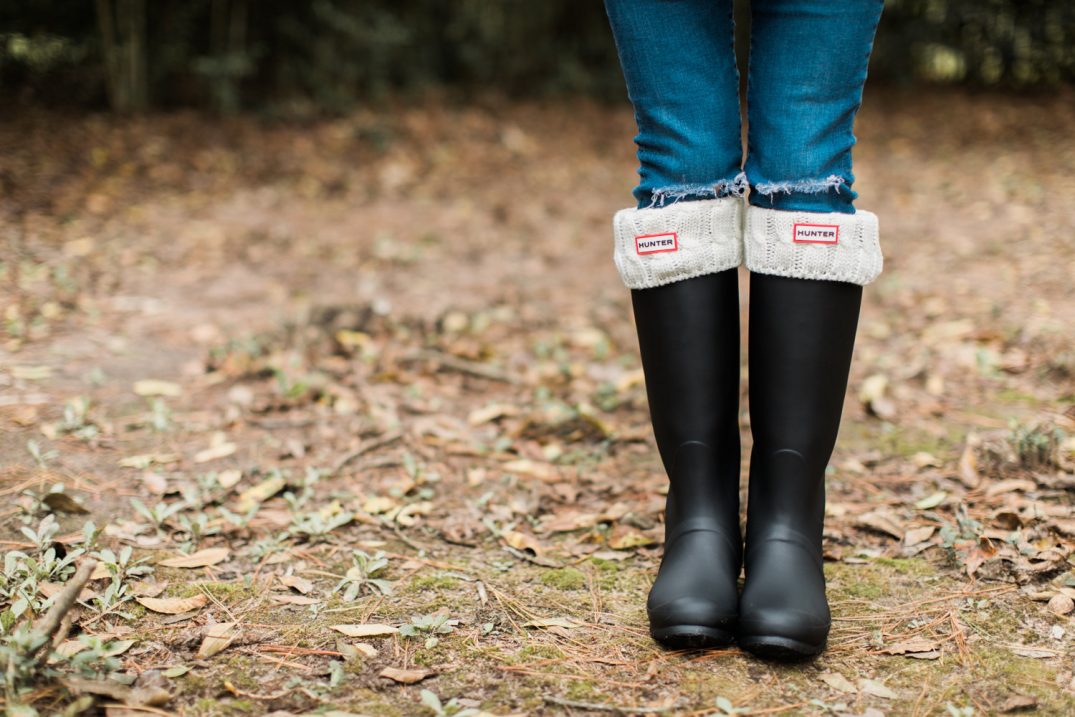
[743,205,884,286]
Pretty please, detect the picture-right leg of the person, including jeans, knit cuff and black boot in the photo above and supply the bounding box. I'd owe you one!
[737,0,883,659]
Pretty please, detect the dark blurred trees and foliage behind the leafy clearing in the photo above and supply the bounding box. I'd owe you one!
[0,0,1075,114]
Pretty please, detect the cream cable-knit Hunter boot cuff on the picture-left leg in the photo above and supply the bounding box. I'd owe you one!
[613,197,743,289]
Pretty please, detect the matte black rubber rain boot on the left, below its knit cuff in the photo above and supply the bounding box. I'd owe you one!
[631,269,743,648]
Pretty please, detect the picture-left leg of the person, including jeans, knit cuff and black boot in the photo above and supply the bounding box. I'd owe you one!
[605,0,744,647]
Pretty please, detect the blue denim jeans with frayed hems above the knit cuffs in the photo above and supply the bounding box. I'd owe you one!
[605,0,884,214]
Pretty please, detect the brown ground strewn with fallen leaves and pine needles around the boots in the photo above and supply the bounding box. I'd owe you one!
[0,89,1075,717]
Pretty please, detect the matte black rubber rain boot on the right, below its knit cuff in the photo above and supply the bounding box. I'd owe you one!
[737,273,862,660]
